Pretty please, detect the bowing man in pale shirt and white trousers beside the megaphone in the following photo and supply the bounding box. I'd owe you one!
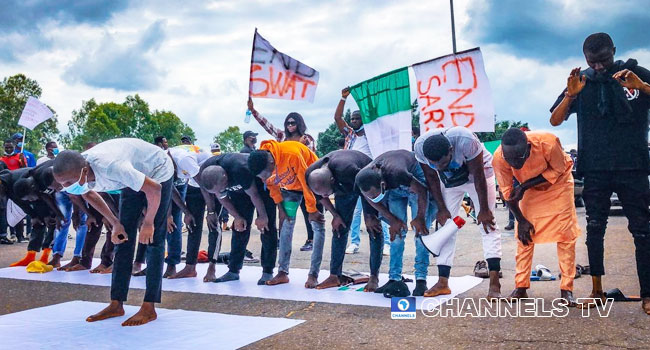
[413,126,501,299]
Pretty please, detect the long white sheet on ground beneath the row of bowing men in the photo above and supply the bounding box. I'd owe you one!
[0,259,482,309]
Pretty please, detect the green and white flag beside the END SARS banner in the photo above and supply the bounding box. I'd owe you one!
[350,67,411,158]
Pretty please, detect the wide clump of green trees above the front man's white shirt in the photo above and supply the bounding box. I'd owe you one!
[61,95,194,150]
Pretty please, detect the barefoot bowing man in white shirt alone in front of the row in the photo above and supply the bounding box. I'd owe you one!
[53,138,174,326]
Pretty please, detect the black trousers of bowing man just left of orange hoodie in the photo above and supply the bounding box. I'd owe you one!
[208,179,278,273]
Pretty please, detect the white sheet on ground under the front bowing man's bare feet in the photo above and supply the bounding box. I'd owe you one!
[0,301,304,349]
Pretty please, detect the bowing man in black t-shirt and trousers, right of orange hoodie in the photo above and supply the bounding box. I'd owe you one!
[305,150,384,292]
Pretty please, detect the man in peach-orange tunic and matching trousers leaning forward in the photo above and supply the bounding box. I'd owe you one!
[492,128,580,306]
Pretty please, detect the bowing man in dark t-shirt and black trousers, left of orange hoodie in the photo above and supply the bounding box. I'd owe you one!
[199,153,278,285]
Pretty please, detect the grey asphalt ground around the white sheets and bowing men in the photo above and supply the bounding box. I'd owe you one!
[0,207,650,349]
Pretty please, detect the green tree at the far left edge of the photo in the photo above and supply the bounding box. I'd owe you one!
[0,74,59,154]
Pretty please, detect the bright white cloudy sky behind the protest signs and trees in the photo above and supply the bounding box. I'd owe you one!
[0,0,650,150]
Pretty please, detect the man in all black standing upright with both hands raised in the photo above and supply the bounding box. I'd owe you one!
[551,33,650,315]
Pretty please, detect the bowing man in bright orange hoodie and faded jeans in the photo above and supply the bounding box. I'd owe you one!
[248,140,325,288]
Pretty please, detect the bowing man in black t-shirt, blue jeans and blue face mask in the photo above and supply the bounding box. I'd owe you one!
[355,150,437,296]
